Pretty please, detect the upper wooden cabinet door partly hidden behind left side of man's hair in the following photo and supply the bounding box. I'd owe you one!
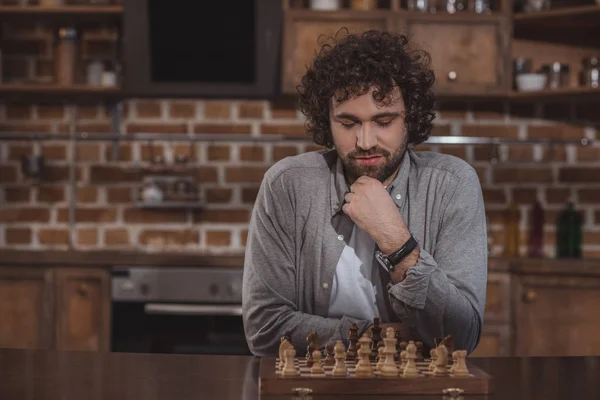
[282,10,392,94]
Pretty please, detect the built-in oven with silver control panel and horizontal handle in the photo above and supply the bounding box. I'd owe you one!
[111,266,251,355]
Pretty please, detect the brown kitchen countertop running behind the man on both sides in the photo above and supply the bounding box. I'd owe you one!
[0,250,600,276]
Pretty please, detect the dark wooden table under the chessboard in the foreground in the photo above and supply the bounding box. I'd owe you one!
[0,349,600,400]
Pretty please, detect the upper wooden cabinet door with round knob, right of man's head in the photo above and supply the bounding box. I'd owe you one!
[402,17,509,94]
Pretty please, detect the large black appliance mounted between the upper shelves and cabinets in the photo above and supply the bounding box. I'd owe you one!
[123,0,283,98]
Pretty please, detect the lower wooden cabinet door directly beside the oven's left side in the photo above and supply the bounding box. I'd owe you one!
[56,268,110,351]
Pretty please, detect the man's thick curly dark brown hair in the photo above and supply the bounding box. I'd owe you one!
[297,30,435,148]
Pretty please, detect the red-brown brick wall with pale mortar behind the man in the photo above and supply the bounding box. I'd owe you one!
[0,100,600,257]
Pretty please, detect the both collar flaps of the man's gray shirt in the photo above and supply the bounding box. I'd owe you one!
[330,149,412,215]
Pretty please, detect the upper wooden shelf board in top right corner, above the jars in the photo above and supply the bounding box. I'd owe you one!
[513,5,600,47]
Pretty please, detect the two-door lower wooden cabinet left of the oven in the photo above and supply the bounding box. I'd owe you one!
[0,266,110,351]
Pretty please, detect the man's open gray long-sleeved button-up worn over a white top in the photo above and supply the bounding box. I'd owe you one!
[242,149,487,356]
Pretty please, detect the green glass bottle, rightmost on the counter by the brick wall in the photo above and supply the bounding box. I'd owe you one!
[556,202,583,258]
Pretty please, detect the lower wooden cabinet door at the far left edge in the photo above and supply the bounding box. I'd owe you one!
[0,266,54,349]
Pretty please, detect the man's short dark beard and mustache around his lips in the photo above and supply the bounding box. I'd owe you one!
[342,140,407,183]
